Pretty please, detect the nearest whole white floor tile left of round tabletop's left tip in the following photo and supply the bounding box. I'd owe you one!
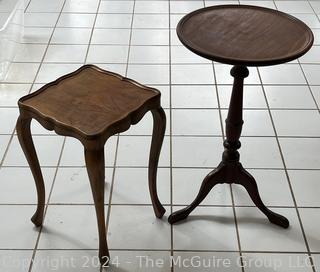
[131,29,169,45]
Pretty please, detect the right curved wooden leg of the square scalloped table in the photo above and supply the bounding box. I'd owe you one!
[148,107,166,218]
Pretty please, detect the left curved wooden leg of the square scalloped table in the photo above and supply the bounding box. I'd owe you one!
[16,115,45,227]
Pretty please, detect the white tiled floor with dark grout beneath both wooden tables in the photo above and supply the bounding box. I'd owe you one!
[0,0,320,272]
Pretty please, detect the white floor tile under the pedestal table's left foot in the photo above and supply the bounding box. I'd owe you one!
[173,207,238,251]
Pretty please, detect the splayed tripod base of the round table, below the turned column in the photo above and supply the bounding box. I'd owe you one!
[168,161,289,228]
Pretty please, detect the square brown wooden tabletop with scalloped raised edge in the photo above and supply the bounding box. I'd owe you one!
[19,65,160,139]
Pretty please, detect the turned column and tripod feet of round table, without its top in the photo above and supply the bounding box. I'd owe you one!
[168,66,289,228]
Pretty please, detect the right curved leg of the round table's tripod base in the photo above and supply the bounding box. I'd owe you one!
[239,167,289,228]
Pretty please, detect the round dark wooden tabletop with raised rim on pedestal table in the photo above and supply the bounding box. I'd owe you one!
[177,5,313,66]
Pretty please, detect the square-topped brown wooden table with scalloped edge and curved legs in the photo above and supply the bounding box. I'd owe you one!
[17,65,166,265]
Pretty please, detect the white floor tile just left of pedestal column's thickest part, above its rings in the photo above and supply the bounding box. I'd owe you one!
[172,109,222,136]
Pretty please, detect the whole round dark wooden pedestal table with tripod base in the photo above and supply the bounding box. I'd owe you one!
[168,5,314,228]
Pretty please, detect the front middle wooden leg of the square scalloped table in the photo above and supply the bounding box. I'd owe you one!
[85,148,109,265]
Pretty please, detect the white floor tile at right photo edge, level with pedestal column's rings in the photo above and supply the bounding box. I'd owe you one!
[279,138,320,169]
